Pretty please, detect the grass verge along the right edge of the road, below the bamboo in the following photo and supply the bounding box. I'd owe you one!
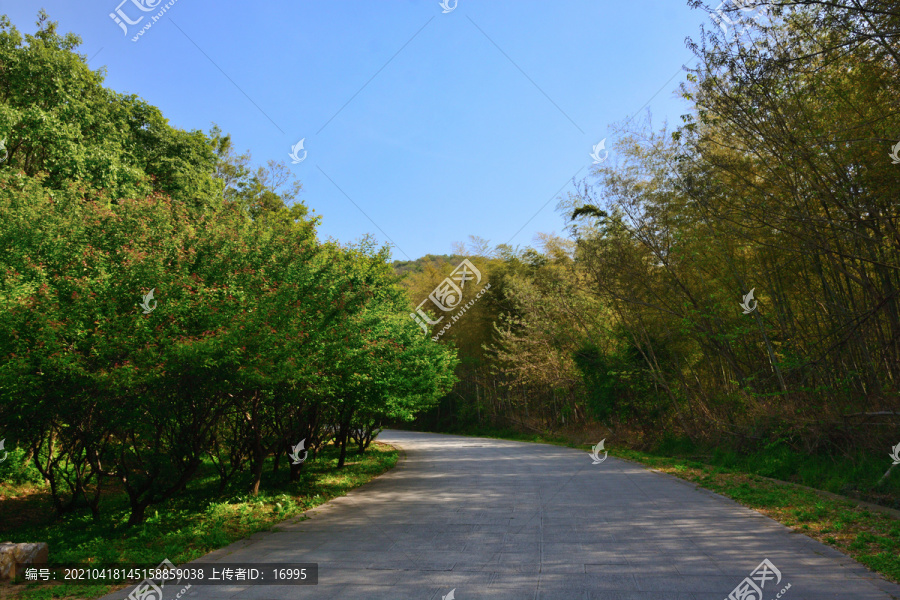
[436,428,900,583]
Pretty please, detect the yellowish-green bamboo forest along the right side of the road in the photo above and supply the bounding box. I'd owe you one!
[395,1,900,503]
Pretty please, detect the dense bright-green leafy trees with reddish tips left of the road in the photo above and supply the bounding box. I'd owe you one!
[0,12,456,525]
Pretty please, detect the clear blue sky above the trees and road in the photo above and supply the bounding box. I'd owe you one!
[0,0,711,260]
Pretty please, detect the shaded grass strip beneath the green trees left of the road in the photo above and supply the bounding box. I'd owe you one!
[0,442,398,600]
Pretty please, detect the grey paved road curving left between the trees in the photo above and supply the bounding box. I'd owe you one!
[102,431,900,600]
